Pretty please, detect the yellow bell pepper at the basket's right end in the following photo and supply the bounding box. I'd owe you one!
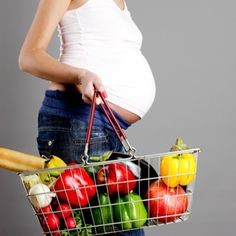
[160,153,196,187]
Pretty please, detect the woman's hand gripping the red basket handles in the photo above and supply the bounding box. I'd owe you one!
[76,69,107,105]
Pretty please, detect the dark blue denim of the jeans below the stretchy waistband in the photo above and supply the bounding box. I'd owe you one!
[37,113,145,236]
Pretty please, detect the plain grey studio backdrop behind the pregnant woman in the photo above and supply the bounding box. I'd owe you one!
[0,0,236,236]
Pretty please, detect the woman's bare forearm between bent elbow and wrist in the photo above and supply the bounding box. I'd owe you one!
[19,49,85,84]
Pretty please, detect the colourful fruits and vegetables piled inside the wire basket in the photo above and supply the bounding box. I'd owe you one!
[23,138,196,236]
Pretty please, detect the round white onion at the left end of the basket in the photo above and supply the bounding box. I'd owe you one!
[29,184,56,208]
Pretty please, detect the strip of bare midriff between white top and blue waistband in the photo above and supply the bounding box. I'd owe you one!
[48,83,140,124]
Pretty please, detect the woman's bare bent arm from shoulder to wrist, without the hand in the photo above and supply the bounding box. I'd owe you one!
[19,0,83,83]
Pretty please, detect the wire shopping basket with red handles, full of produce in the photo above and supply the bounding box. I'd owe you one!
[16,91,200,236]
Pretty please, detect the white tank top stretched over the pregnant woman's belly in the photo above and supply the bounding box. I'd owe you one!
[57,0,156,118]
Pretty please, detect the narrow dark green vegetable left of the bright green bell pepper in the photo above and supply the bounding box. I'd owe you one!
[92,193,112,232]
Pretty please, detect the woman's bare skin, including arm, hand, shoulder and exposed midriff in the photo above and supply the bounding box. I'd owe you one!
[18,0,140,123]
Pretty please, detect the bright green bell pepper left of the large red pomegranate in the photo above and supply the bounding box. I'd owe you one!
[113,192,148,229]
